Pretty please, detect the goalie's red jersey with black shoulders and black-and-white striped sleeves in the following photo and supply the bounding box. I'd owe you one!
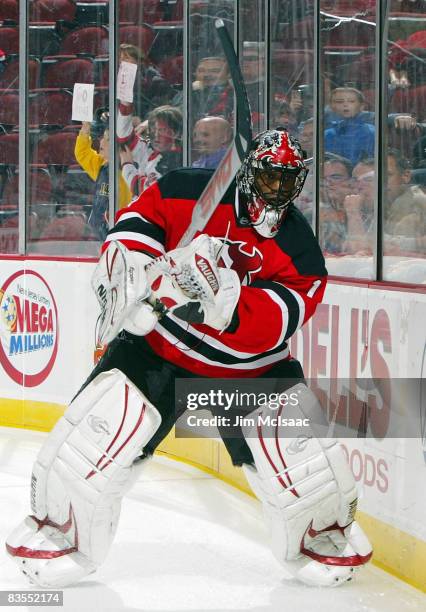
[104,168,327,377]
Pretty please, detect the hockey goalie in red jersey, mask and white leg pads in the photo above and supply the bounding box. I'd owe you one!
[6,128,372,588]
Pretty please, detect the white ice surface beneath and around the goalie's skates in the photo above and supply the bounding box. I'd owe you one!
[0,428,426,612]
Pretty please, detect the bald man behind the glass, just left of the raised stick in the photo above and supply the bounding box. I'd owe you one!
[191,117,233,168]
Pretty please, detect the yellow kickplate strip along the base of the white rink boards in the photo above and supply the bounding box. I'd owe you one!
[0,399,426,592]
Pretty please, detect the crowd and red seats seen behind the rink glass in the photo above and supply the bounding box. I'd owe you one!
[0,0,426,278]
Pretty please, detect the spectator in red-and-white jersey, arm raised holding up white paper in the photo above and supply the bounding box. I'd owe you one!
[117,102,182,196]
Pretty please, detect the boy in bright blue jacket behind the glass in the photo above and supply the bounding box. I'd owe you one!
[324,87,374,164]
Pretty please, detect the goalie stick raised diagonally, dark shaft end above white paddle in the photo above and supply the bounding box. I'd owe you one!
[177,19,252,247]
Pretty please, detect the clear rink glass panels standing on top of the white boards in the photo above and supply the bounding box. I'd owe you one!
[0,0,426,284]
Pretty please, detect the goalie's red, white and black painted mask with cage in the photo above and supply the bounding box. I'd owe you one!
[237,128,308,238]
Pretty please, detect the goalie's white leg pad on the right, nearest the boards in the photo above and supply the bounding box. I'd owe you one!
[242,383,372,586]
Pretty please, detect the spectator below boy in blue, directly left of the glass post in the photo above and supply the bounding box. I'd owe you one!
[343,158,375,255]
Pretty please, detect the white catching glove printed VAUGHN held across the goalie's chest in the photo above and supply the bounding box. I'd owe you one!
[146,234,241,331]
